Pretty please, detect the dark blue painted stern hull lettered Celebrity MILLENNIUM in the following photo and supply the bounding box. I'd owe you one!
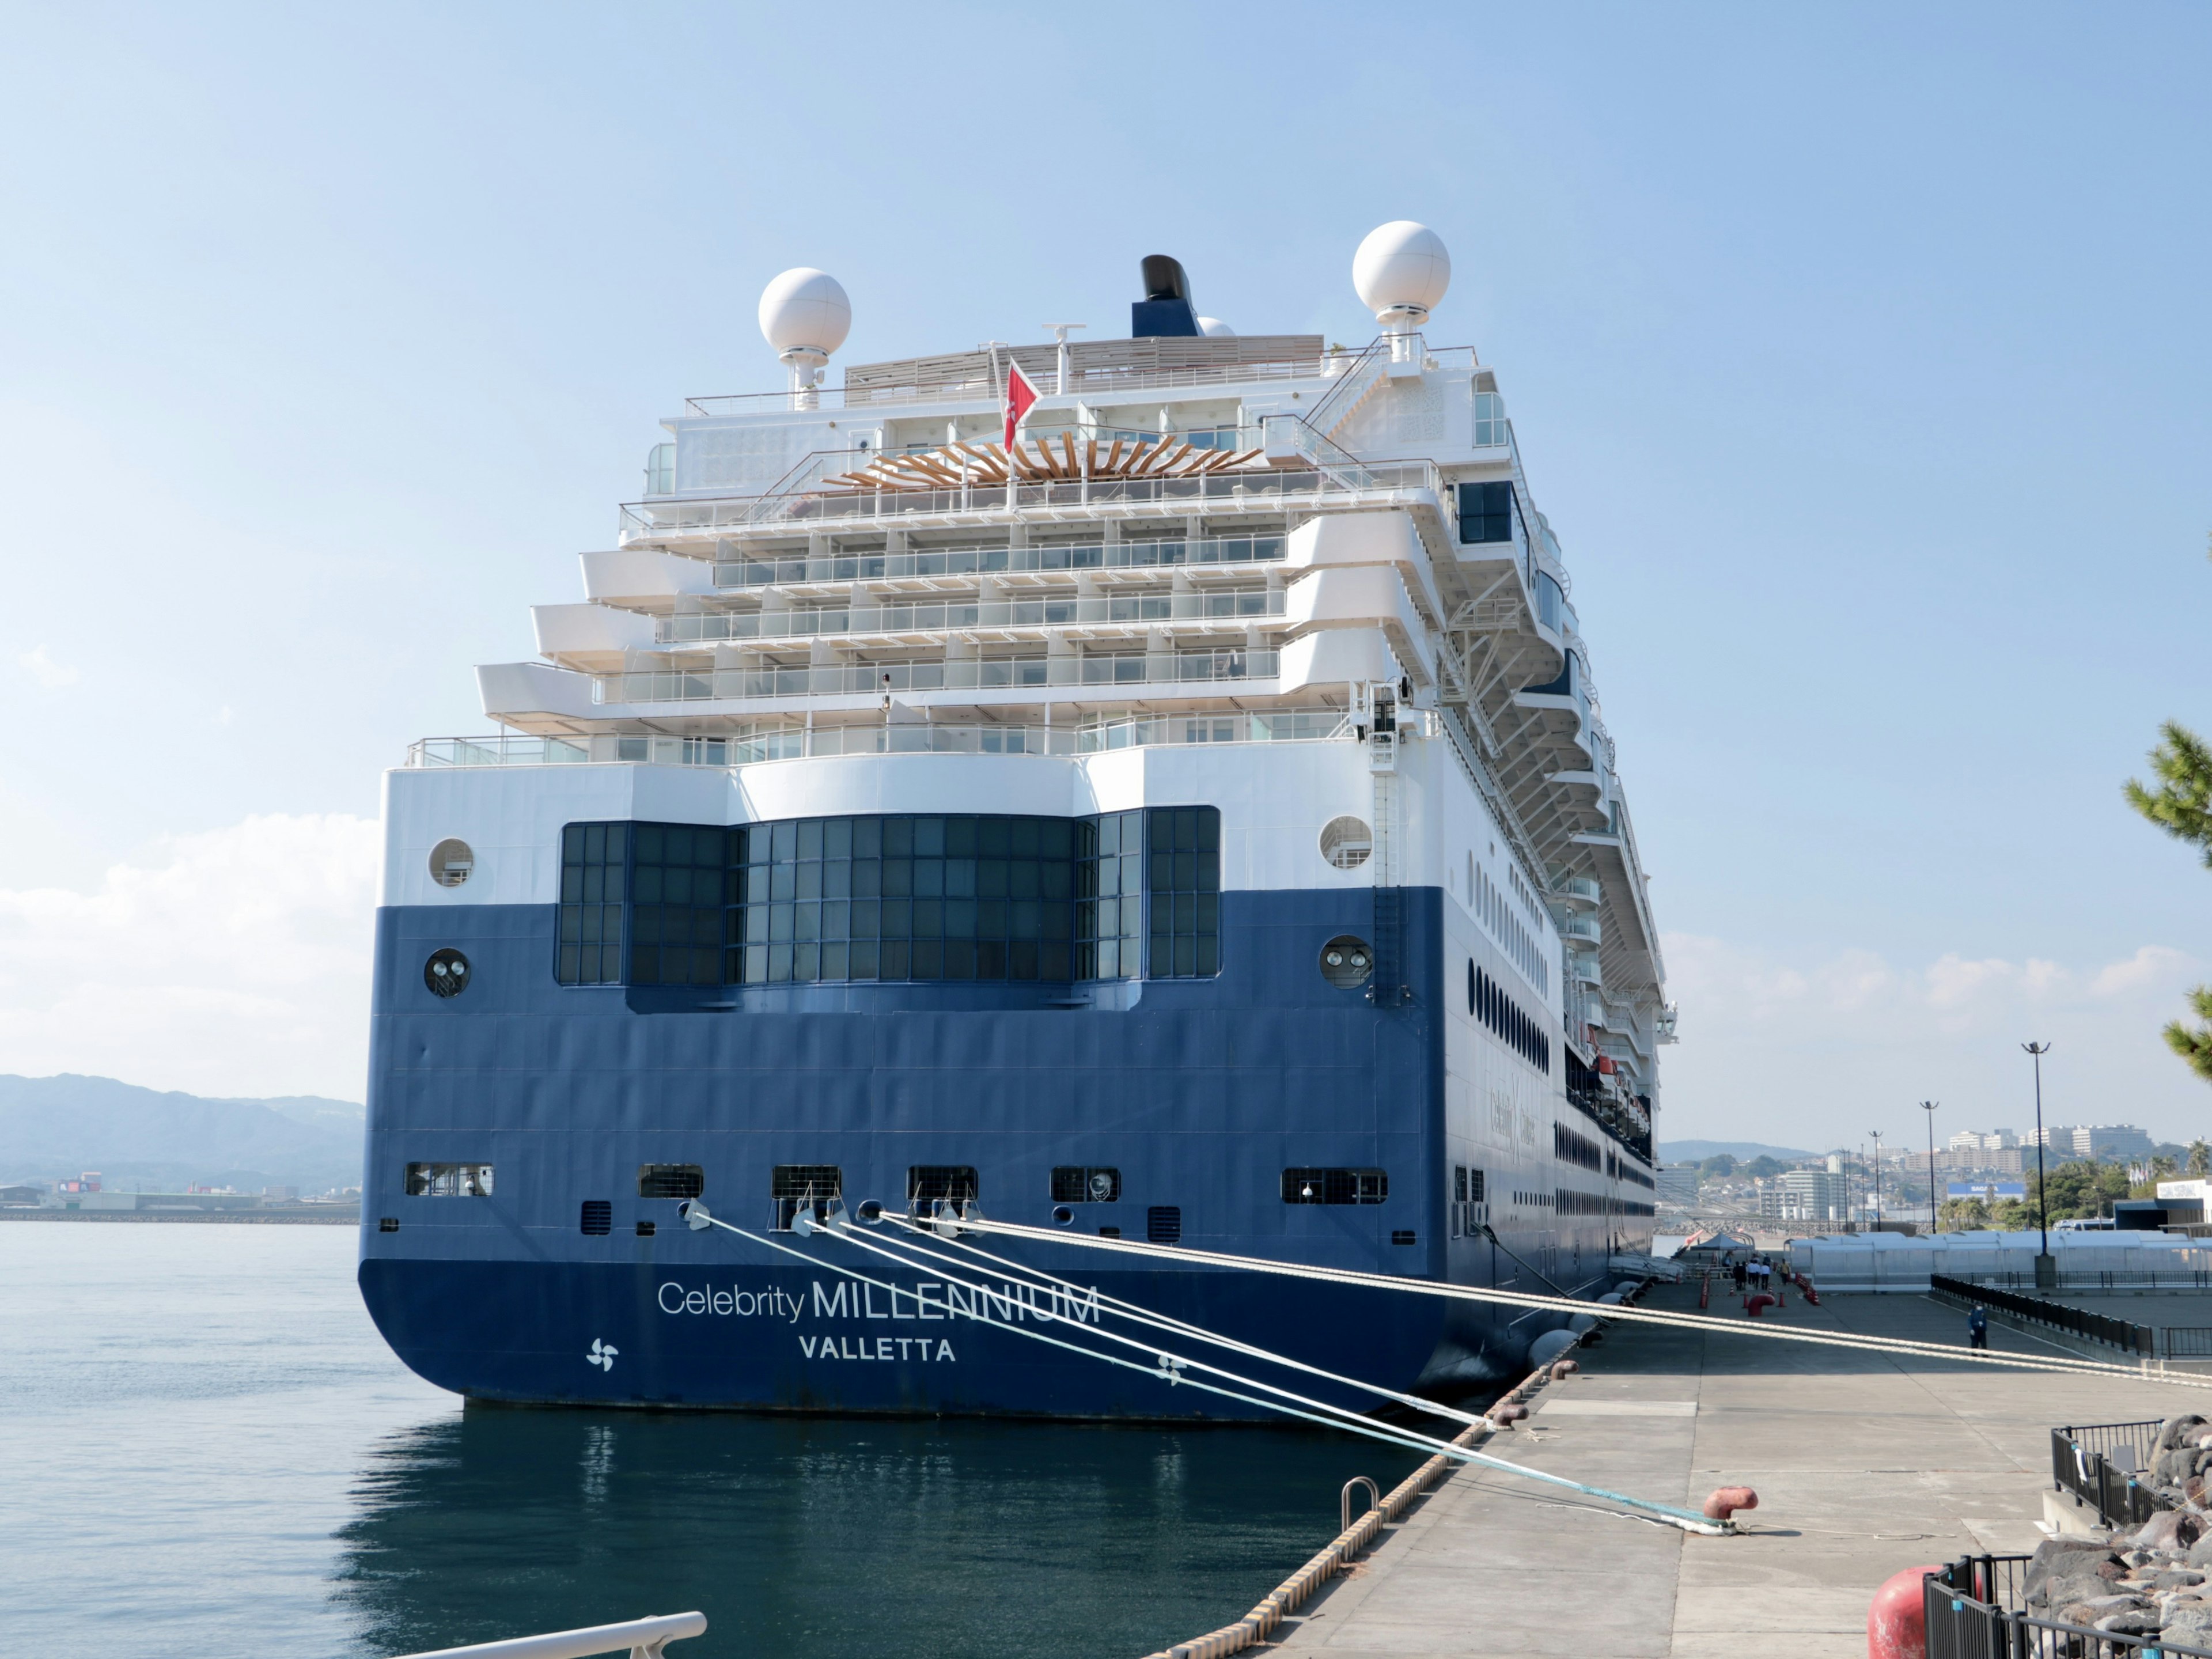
[361,889,1617,1418]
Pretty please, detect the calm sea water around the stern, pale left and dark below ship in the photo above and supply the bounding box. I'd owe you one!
[0,1221,1416,1659]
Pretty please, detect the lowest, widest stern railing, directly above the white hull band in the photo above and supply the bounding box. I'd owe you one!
[407,708,1351,770]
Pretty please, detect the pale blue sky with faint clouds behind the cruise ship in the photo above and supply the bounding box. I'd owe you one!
[0,5,2212,1143]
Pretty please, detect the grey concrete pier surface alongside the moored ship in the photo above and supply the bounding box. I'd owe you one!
[1281,1287,2185,1659]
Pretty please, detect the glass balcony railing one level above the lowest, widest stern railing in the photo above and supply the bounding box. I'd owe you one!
[590,650,1279,703]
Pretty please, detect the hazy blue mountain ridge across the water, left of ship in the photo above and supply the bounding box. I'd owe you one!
[0,1073,367,1192]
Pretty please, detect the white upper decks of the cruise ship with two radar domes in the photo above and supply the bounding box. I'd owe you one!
[407,224,1675,1159]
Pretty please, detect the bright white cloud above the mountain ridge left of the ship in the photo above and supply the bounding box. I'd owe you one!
[0,814,378,1099]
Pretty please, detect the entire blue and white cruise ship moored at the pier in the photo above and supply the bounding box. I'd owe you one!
[358,221,1675,1420]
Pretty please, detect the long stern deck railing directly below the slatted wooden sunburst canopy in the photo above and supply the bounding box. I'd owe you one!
[619,460,1449,544]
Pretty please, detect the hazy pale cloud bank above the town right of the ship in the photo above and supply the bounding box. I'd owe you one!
[1659,933,2212,1150]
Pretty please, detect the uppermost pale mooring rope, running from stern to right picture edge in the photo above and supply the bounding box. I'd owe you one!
[958,1219,2212,1389]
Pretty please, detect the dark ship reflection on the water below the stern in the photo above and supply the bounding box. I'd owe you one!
[336,1409,1418,1659]
